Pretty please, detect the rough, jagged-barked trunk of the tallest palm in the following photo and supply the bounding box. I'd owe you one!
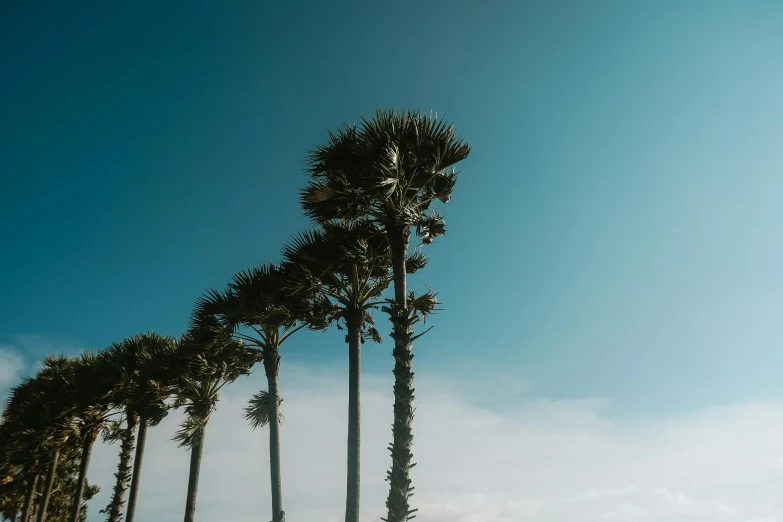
[386,226,416,522]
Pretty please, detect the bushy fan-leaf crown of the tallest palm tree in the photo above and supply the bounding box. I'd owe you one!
[301,109,470,243]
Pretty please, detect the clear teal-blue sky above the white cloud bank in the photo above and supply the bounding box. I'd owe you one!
[0,0,783,522]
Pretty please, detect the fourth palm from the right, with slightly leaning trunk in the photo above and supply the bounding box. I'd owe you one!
[174,324,256,522]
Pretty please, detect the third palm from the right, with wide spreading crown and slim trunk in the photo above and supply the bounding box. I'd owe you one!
[198,264,327,522]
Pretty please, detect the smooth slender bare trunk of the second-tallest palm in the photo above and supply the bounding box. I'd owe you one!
[345,319,362,522]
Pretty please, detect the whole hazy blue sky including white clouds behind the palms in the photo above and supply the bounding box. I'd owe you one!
[0,0,783,522]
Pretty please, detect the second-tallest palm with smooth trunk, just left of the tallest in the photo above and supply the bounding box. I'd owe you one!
[283,221,416,522]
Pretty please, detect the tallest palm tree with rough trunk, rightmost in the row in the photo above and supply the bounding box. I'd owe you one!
[301,109,470,522]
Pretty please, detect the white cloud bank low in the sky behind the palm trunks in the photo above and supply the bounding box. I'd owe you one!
[53,365,783,522]
